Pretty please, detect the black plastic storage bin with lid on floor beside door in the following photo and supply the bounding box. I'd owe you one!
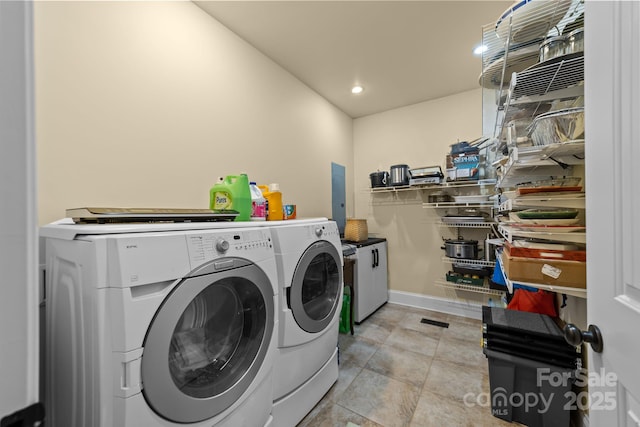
[482,306,582,427]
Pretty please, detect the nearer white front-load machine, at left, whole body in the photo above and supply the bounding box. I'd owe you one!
[41,224,278,427]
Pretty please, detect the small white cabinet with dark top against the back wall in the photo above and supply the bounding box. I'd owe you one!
[353,239,389,323]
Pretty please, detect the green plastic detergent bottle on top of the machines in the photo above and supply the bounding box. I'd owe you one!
[209,174,251,221]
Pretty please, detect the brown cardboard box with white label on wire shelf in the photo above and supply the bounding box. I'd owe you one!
[500,252,587,289]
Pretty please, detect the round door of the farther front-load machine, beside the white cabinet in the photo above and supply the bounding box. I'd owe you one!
[290,241,342,333]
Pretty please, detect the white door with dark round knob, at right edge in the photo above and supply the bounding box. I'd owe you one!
[585,1,640,427]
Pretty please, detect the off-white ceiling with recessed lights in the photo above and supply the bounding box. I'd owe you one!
[195,0,513,118]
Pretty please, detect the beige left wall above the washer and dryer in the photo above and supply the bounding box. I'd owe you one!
[34,1,353,224]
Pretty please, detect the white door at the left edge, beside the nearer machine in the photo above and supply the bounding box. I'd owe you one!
[0,1,42,425]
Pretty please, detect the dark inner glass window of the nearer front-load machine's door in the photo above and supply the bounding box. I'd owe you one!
[169,277,258,398]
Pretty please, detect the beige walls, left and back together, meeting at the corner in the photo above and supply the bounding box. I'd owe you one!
[35,2,500,308]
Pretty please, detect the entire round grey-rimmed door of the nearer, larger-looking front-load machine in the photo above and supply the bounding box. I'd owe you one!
[142,265,274,423]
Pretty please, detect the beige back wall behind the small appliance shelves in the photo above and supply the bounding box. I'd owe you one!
[354,89,486,301]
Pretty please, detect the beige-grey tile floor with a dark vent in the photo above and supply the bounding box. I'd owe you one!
[298,303,518,427]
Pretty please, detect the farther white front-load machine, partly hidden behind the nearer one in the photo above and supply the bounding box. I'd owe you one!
[271,218,343,427]
